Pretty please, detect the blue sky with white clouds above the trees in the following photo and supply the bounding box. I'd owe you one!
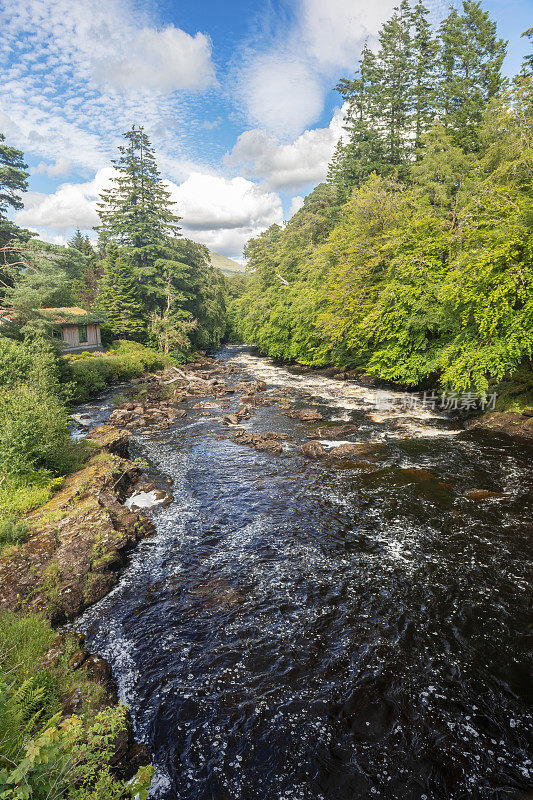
[0,0,533,260]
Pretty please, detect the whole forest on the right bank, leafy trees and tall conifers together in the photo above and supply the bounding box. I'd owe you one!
[230,0,533,392]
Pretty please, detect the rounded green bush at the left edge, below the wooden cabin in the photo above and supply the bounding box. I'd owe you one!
[0,384,79,475]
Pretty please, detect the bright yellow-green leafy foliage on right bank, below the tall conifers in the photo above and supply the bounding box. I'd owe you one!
[234,65,533,392]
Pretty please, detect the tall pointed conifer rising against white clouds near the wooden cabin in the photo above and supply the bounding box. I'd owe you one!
[97,126,183,305]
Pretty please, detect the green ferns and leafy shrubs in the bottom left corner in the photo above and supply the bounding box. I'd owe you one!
[0,611,153,800]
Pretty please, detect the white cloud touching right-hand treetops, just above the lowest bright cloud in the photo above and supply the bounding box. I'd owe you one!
[224,104,344,189]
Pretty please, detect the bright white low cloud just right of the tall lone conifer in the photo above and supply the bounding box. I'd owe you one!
[168,172,283,258]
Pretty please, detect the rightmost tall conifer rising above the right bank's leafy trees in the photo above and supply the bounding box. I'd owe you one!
[439,0,507,151]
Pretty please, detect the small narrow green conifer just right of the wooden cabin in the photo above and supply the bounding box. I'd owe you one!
[98,243,146,340]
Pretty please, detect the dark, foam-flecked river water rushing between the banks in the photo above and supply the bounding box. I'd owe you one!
[74,348,533,800]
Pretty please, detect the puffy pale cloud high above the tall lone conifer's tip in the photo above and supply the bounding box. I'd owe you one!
[94,25,216,92]
